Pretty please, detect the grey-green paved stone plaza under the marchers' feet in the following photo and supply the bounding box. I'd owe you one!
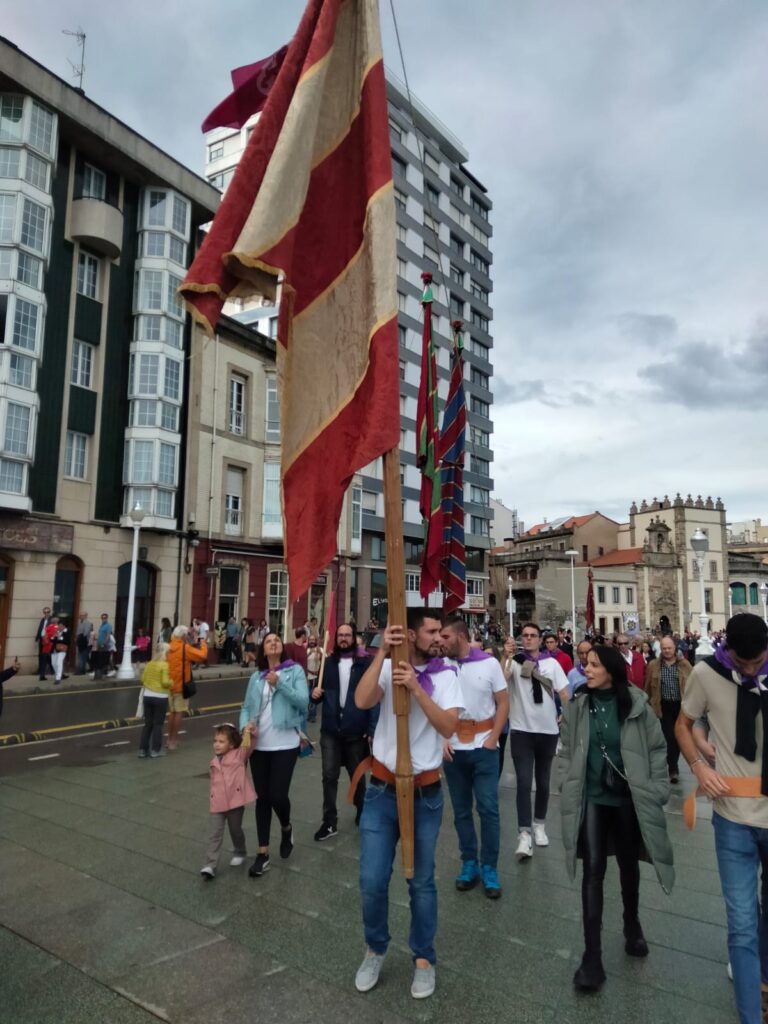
[0,733,736,1024]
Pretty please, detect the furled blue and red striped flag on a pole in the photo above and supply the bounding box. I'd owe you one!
[440,321,467,611]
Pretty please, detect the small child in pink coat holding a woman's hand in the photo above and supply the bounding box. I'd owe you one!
[200,722,256,882]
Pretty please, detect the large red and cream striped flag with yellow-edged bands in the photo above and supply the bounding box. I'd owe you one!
[181,0,399,600]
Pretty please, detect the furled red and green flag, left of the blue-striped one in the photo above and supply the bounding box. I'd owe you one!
[416,270,442,598]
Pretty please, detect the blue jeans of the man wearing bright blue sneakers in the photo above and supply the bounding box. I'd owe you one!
[442,746,500,867]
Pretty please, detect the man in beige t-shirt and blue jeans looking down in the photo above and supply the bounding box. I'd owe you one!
[676,613,768,1024]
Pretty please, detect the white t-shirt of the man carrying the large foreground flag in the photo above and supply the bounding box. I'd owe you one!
[374,658,464,775]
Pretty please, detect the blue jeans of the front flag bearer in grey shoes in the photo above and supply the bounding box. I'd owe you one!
[360,780,442,964]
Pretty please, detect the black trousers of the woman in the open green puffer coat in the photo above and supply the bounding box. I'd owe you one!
[579,800,642,956]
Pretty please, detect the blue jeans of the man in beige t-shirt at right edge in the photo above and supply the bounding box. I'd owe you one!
[712,812,768,1024]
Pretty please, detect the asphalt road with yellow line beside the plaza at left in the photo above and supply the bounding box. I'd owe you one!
[0,674,248,777]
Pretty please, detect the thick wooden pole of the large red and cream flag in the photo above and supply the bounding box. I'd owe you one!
[383,447,414,879]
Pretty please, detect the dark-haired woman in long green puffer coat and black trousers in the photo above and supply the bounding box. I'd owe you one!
[560,646,675,991]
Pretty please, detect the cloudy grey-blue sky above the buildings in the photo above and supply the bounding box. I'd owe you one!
[7,0,768,524]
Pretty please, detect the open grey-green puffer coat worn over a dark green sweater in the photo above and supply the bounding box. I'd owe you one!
[560,686,675,893]
